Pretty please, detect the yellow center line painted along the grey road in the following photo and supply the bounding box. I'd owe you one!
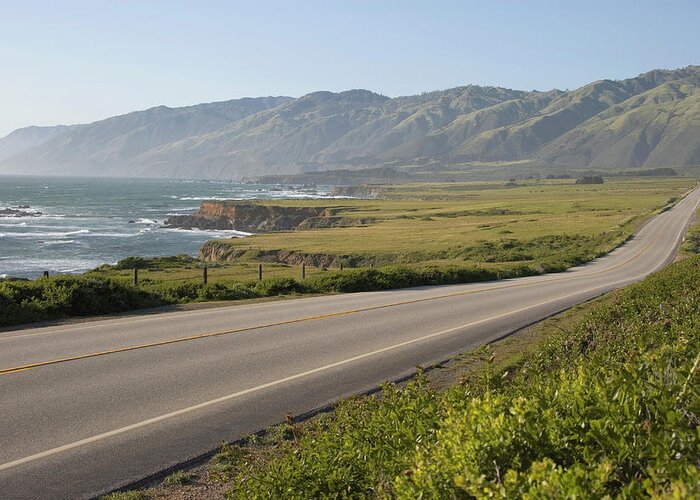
[0,229,658,376]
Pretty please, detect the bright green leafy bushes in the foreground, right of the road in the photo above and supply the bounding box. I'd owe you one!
[225,257,700,498]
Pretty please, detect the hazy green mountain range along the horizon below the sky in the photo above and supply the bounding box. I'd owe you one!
[0,66,700,179]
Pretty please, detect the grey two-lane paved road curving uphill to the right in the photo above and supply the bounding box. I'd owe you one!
[0,189,700,498]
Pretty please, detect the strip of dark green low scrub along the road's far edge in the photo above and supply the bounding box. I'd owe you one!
[0,266,538,326]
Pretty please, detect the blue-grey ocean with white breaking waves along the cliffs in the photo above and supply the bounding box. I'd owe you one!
[0,176,330,278]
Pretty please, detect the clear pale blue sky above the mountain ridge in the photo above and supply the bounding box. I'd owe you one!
[0,0,700,137]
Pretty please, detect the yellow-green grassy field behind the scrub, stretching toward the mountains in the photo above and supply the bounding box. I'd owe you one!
[197,178,694,266]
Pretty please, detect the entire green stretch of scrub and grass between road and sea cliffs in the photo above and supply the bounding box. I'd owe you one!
[0,178,692,326]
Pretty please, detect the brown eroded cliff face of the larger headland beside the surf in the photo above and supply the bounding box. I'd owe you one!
[165,201,373,233]
